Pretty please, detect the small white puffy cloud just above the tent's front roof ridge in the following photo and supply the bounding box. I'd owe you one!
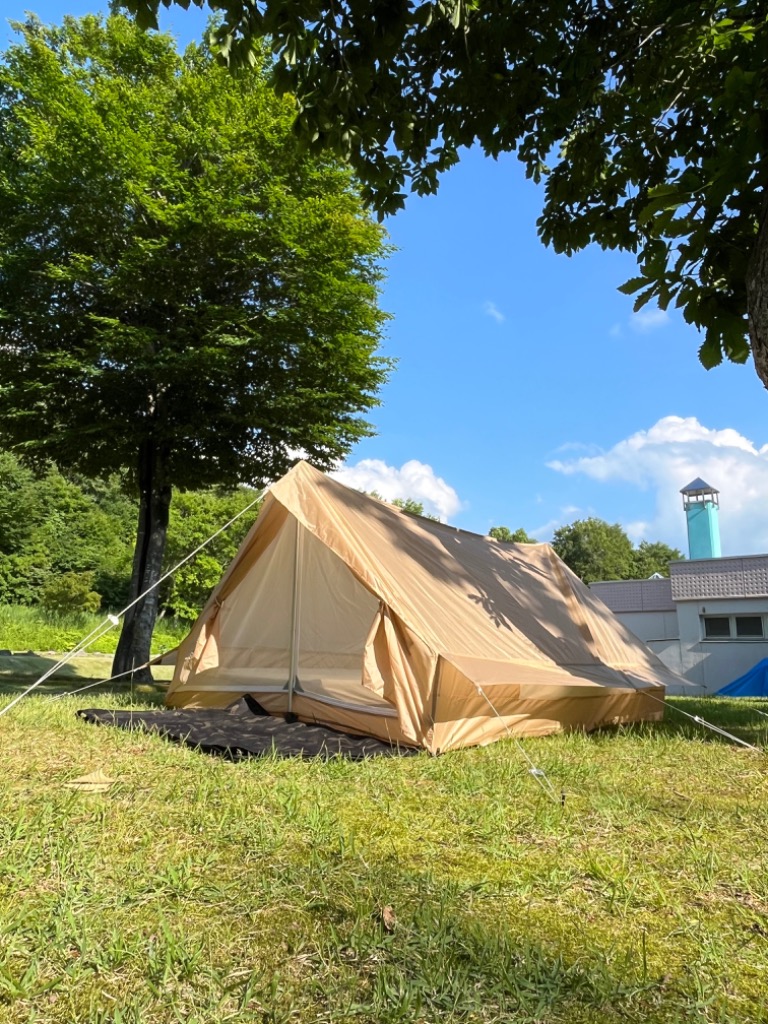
[331,459,462,520]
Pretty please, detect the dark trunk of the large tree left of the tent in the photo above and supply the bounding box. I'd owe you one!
[112,440,171,683]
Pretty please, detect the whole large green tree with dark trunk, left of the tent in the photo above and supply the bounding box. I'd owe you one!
[0,15,388,672]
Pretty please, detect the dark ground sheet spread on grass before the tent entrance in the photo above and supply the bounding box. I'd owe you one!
[77,697,416,761]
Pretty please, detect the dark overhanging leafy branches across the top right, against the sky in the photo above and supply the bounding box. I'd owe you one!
[125,0,768,386]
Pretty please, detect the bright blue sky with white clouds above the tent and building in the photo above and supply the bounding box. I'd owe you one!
[2,0,768,555]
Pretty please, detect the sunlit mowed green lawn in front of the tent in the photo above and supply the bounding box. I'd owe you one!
[0,685,768,1024]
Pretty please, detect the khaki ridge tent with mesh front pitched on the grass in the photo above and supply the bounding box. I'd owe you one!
[168,463,680,753]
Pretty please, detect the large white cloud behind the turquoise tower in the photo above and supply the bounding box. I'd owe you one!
[548,416,768,555]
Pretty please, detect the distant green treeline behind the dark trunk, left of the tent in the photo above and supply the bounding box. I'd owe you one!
[0,452,258,620]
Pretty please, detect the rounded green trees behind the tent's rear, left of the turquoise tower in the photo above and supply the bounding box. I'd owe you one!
[552,517,683,583]
